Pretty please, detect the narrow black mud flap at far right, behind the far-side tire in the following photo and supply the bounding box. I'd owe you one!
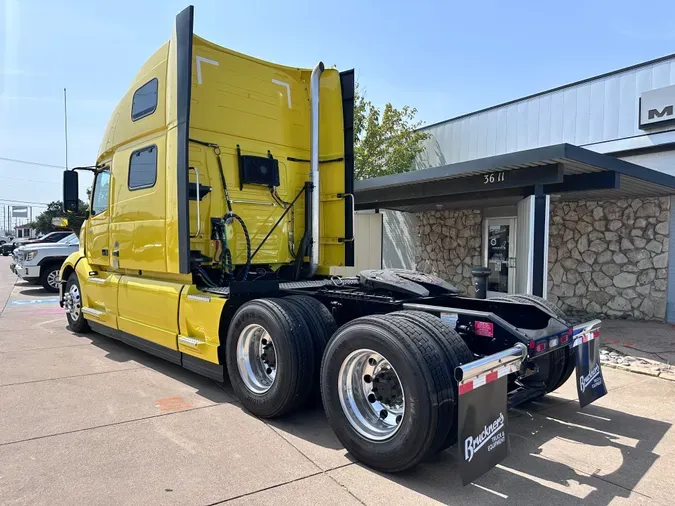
[572,320,607,408]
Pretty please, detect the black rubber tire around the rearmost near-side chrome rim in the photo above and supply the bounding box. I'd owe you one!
[321,314,453,472]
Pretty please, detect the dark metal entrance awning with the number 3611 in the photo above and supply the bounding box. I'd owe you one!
[354,144,675,212]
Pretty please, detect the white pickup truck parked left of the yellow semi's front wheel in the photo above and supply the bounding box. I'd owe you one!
[10,234,80,292]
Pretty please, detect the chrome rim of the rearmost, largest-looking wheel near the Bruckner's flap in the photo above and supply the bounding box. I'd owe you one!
[338,348,405,441]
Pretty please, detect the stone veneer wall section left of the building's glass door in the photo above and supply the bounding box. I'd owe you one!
[415,209,483,296]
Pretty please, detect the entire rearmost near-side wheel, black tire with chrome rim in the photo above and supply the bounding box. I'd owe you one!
[321,311,470,472]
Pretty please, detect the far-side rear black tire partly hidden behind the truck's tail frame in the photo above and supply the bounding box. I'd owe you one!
[490,294,575,393]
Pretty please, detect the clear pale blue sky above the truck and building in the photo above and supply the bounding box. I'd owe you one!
[0,0,675,219]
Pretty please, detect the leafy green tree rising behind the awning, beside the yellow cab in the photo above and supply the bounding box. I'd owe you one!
[354,84,430,179]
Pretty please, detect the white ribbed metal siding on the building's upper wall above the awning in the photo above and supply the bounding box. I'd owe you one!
[417,57,675,168]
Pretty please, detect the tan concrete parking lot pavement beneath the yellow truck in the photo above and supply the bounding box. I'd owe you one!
[0,257,675,506]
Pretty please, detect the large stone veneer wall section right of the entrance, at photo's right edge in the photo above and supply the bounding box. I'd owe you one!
[548,197,670,320]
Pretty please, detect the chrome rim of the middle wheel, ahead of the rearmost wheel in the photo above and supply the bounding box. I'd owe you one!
[237,323,277,395]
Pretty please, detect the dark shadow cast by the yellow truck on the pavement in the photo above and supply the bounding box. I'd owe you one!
[71,326,672,506]
